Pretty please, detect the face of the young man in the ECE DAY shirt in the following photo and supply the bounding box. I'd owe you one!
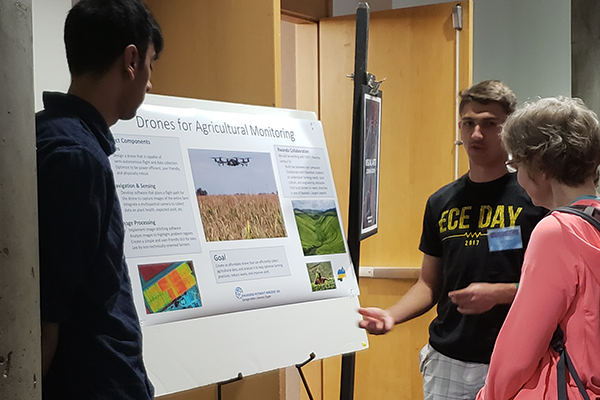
[458,101,507,167]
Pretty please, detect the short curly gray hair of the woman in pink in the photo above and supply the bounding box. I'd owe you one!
[501,97,600,187]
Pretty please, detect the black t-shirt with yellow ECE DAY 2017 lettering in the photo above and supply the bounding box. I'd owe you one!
[419,174,546,363]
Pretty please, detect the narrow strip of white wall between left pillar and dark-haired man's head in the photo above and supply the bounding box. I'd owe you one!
[32,0,71,111]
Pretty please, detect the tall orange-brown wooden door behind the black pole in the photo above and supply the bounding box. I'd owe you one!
[320,1,472,400]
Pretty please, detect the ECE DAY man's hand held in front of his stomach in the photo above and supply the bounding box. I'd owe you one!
[448,282,504,314]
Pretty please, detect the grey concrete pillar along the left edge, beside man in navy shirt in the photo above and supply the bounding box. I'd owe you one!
[0,0,41,400]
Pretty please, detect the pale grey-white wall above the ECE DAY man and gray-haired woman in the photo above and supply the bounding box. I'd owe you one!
[473,0,571,103]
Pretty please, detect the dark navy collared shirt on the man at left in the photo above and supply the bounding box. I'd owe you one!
[36,93,154,400]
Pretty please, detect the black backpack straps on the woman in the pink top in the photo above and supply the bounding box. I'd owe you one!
[550,205,600,400]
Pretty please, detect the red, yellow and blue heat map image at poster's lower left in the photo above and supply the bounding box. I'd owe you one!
[138,261,202,314]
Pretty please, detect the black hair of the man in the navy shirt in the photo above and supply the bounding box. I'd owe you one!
[65,0,164,76]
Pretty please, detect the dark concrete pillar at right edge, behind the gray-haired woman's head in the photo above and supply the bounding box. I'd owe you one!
[571,0,600,114]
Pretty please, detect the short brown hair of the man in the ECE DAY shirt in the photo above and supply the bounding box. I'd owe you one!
[458,80,517,115]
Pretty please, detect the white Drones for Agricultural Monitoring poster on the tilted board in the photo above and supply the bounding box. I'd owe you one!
[111,99,358,326]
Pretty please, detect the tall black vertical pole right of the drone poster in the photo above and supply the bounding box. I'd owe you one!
[340,3,369,400]
